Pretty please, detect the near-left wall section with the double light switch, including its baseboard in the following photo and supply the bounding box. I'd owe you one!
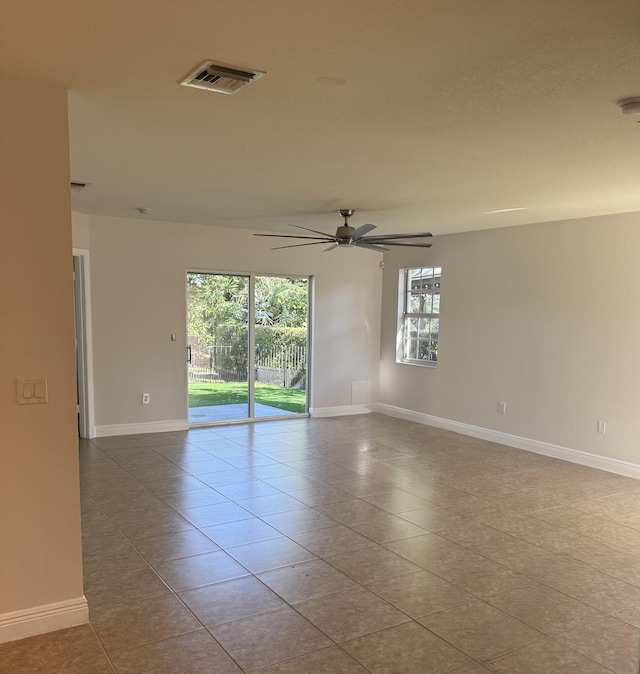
[0,80,87,642]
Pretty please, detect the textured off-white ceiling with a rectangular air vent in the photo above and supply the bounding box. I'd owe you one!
[0,0,640,234]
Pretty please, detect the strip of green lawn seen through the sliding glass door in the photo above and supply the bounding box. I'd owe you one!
[189,381,306,412]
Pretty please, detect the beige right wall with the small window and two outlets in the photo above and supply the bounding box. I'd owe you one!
[380,213,640,464]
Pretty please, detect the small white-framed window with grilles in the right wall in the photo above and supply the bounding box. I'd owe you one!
[398,267,442,367]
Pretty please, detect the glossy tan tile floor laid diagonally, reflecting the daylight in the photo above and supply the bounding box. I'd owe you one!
[0,414,640,674]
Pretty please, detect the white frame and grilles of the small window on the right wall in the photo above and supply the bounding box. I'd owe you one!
[396,266,442,368]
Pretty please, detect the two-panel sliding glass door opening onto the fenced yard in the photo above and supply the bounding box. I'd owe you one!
[187,271,310,425]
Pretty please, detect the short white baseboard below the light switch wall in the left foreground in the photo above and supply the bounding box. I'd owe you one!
[0,597,89,644]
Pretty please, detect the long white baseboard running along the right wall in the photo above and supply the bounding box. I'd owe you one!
[371,403,640,480]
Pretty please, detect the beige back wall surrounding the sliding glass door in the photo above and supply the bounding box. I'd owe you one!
[74,216,382,433]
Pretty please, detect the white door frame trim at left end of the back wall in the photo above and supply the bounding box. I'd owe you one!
[73,248,96,438]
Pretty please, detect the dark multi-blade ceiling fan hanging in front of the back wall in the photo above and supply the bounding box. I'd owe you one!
[254,208,433,253]
